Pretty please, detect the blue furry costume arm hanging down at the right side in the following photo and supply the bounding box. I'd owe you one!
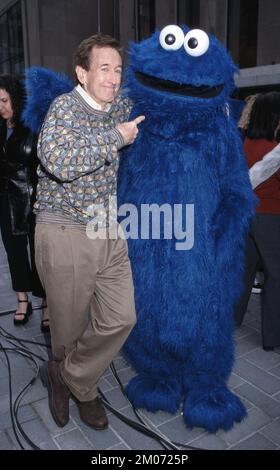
[214,122,256,244]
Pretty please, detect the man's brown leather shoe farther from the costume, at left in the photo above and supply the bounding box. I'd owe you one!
[40,361,70,427]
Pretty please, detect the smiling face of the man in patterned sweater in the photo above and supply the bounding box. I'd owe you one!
[76,47,122,109]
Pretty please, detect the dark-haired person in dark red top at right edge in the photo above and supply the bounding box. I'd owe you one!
[235,92,280,351]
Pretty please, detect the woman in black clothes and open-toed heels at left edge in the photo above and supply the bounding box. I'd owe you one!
[0,75,49,332]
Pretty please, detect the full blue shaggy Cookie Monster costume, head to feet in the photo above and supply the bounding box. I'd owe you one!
[118,27,255,432]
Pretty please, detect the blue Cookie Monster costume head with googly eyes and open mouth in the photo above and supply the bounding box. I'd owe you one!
[126,25,238,112]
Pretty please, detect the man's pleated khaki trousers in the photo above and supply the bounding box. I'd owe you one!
[35,224,136,401]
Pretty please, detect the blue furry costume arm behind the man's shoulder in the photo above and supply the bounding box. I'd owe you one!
[22,66,74,134]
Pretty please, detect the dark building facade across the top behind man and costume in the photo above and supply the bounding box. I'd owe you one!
[0,0,280,97]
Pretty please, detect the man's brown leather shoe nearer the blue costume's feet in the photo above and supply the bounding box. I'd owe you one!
[78,397,108,430]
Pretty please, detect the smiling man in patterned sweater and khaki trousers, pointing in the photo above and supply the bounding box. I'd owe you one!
[34,35,144,430]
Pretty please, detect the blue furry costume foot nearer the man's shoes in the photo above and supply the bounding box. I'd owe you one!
[126,375,182,413]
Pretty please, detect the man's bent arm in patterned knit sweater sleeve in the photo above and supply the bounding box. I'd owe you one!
[38,95,124,181]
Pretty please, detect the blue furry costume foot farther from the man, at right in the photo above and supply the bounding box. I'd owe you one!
[184,385,247,432]
